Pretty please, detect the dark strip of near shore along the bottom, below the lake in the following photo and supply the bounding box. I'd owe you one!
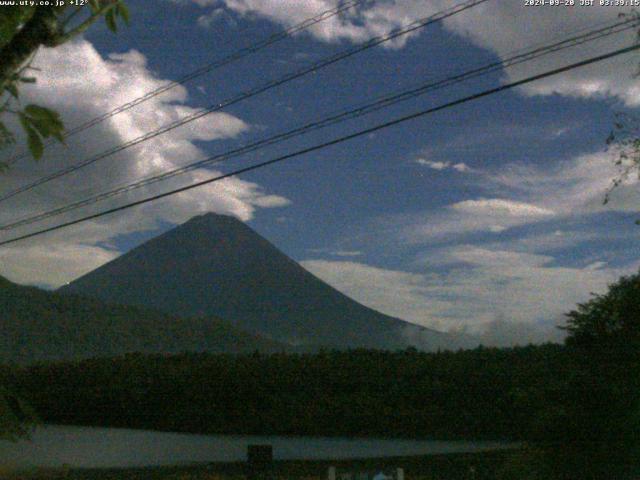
[0,451,514,480]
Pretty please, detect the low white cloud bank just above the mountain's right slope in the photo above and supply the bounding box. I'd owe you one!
[302,253,640,345]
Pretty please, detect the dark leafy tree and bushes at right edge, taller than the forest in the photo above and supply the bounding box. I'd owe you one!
[510,273,640,480]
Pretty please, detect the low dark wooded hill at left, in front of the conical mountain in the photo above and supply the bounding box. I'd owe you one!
[0,277,286,364]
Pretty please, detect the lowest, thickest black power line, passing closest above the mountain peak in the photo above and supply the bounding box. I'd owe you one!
[0,44,640,246]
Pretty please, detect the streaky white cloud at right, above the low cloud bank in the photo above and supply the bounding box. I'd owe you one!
[392,147,640,243]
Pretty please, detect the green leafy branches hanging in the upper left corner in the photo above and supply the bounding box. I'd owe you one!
[0,0,129,165]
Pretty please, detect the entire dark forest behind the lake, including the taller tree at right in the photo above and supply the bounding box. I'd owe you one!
[5,274,640,478]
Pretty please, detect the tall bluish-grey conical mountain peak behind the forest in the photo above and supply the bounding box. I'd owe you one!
[60,213,470,349]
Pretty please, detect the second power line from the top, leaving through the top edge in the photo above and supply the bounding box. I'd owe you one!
[0,0,488,202]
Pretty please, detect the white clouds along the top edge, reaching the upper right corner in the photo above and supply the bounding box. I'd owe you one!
[194,0,640,106]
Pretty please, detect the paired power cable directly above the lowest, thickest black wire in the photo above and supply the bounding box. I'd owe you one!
[0,15,640,231]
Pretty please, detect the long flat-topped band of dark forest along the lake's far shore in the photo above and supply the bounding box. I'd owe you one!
[3,344,570,439]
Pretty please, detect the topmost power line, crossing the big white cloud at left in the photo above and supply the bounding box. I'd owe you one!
[6,0,367,164]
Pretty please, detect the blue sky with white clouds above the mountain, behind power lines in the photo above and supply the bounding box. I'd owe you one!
[0,0,640,345]
